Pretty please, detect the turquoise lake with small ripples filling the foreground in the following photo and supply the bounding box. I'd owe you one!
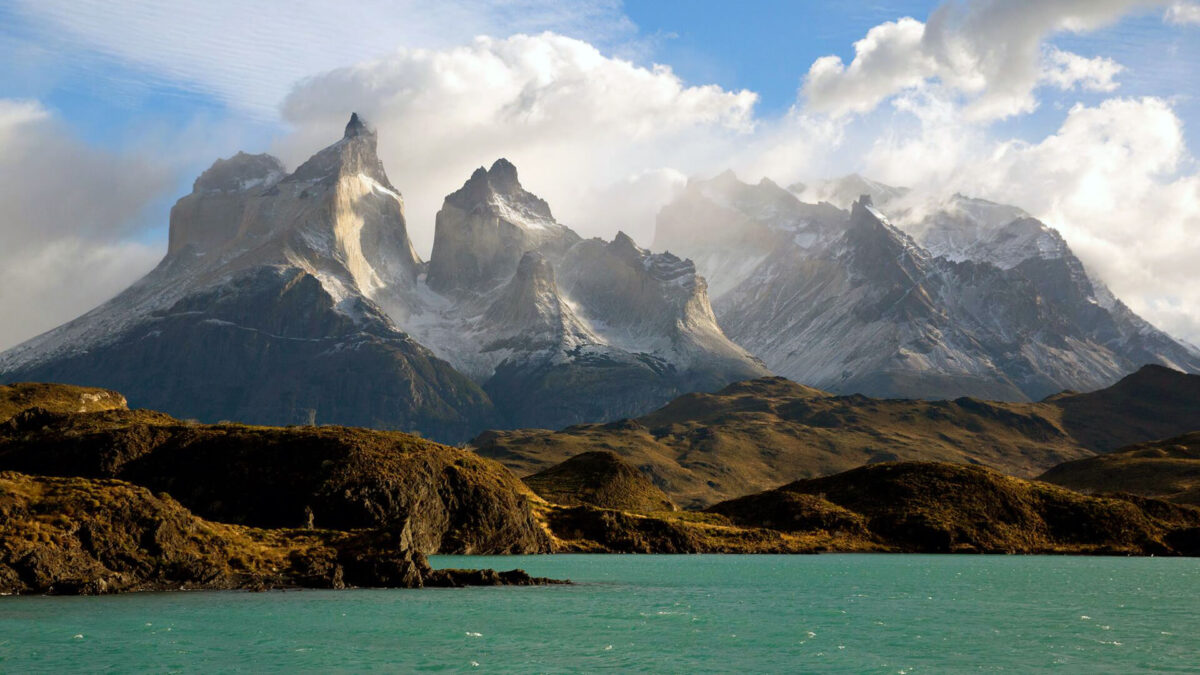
[0,555,1200,674]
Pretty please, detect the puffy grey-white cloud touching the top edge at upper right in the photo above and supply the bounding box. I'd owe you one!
[802,0,1145,120]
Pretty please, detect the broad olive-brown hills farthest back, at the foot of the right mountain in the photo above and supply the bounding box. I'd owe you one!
[472,366,1200,508]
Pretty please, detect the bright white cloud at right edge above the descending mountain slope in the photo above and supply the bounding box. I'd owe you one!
[970,97,1200,340]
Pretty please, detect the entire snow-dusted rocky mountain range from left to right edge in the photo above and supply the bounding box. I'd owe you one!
[0,114,1200,442]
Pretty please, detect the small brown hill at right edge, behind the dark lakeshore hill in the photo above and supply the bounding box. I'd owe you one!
[1038,432,1200,506]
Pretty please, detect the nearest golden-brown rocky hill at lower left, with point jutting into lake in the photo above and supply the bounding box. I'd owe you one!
[0,472,552,595]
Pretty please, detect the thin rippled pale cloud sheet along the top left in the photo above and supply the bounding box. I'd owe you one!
[12,0,634,119]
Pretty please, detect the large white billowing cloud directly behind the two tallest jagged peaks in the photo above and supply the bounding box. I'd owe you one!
[276,32,757,251]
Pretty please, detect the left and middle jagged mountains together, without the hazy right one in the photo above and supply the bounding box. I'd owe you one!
[0,115,764,442]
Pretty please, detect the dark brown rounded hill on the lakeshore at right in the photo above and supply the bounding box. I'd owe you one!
[708,462,1200,555]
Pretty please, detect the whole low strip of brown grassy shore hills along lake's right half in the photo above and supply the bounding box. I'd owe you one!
[540,462,1200,556]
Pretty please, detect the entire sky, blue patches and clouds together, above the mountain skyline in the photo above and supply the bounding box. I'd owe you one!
[0,0,1200,348]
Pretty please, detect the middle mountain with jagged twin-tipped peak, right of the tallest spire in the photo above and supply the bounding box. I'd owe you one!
[408,160,766,426]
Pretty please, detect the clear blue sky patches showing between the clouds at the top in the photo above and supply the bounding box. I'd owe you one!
[0,0,1200,186]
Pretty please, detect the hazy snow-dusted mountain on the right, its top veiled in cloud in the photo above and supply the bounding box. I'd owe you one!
[655,174,1200,400]
